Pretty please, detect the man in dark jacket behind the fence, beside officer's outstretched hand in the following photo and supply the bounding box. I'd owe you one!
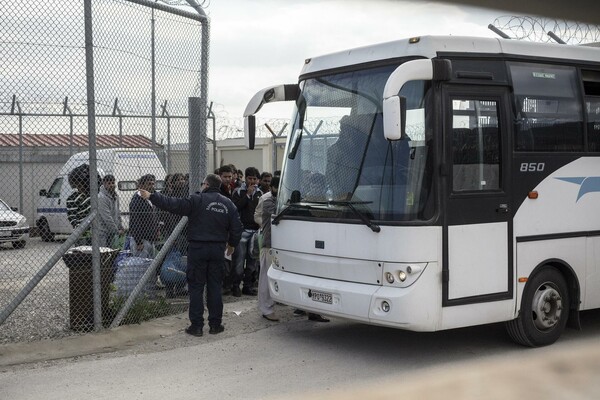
[129,174,158,258]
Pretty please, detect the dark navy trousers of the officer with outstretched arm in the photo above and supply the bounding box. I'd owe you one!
[187,242,225,327]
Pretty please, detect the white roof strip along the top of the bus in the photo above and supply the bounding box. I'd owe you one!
[301,36,600,75]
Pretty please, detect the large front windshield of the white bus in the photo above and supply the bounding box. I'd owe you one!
[278,64,433,222]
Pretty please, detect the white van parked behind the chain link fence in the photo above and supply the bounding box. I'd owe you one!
[36,148,165,241]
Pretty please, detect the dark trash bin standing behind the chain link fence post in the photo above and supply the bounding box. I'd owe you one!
[62,246,119,331]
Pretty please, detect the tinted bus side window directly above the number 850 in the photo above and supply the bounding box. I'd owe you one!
[509,63,584,151]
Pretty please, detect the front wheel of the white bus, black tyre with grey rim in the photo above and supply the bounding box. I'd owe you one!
[506,266,570,347]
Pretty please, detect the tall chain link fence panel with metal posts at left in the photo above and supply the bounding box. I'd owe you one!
[0,0,214,343]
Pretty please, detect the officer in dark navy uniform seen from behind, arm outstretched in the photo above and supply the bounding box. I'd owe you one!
[140,174,242,336]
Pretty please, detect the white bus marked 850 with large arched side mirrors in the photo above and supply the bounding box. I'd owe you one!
[245,36,600,346]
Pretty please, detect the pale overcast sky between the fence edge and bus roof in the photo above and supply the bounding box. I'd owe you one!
[206,0,509,118]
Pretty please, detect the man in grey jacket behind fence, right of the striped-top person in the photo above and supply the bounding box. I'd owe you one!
[98,175,125,247]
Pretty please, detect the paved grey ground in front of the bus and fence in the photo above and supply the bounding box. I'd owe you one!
[0,300,600,400]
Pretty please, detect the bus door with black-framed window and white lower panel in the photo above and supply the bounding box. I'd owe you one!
[442,84,513,306]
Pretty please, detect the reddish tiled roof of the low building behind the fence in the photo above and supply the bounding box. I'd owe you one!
[0,133,162,148]
